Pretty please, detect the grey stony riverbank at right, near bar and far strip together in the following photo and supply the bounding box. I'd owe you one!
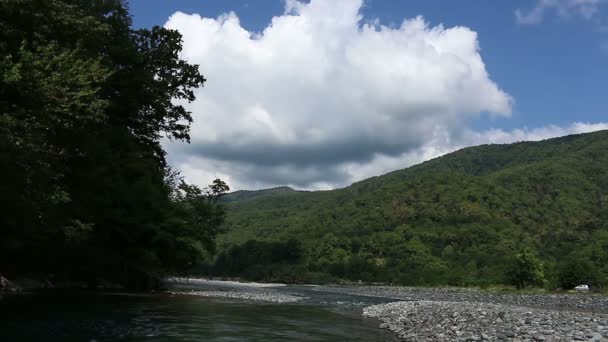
[324,286,608,342]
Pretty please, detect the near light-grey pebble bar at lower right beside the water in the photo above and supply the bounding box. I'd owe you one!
[363,301,608,342]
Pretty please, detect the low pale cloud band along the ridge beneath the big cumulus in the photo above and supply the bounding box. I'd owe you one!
[170,122,608,190]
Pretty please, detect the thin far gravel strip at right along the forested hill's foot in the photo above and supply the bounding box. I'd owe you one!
[322,286,608,314]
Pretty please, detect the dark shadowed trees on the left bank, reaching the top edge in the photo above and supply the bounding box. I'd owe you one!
[0,0,228,288]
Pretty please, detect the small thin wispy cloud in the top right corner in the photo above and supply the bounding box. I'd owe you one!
[515,0,602,25]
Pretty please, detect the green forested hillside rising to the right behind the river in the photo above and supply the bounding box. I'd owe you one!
[213,131,608,288]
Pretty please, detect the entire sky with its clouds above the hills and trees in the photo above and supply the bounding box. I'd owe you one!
[129,0,608,190]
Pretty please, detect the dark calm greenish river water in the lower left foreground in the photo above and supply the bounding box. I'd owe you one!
[0,287,394,342]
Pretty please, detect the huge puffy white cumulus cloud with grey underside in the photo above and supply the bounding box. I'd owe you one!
[166,0,512,187]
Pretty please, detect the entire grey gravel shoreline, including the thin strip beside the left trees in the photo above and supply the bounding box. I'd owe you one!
[4,278,608,342]
